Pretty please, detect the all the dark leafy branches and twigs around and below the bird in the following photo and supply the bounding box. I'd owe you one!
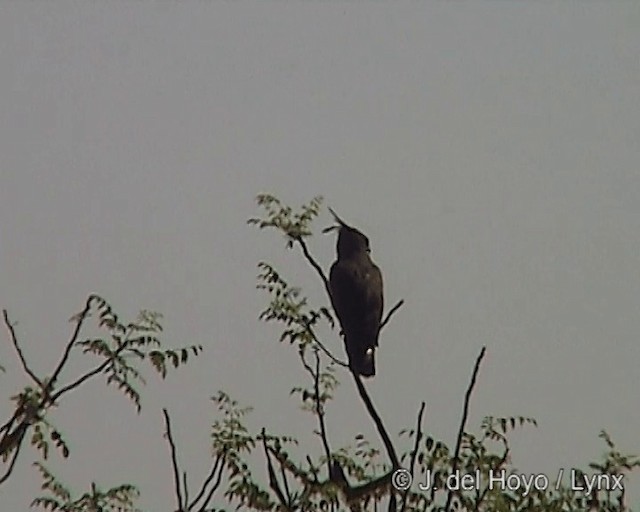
[0,194,640,512]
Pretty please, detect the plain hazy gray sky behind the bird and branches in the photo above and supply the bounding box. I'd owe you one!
[0,1,640,511]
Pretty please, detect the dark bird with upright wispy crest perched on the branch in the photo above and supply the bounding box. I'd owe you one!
[325,208,384,377]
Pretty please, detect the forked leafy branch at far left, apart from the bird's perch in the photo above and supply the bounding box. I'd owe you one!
[0,294,202,484]
